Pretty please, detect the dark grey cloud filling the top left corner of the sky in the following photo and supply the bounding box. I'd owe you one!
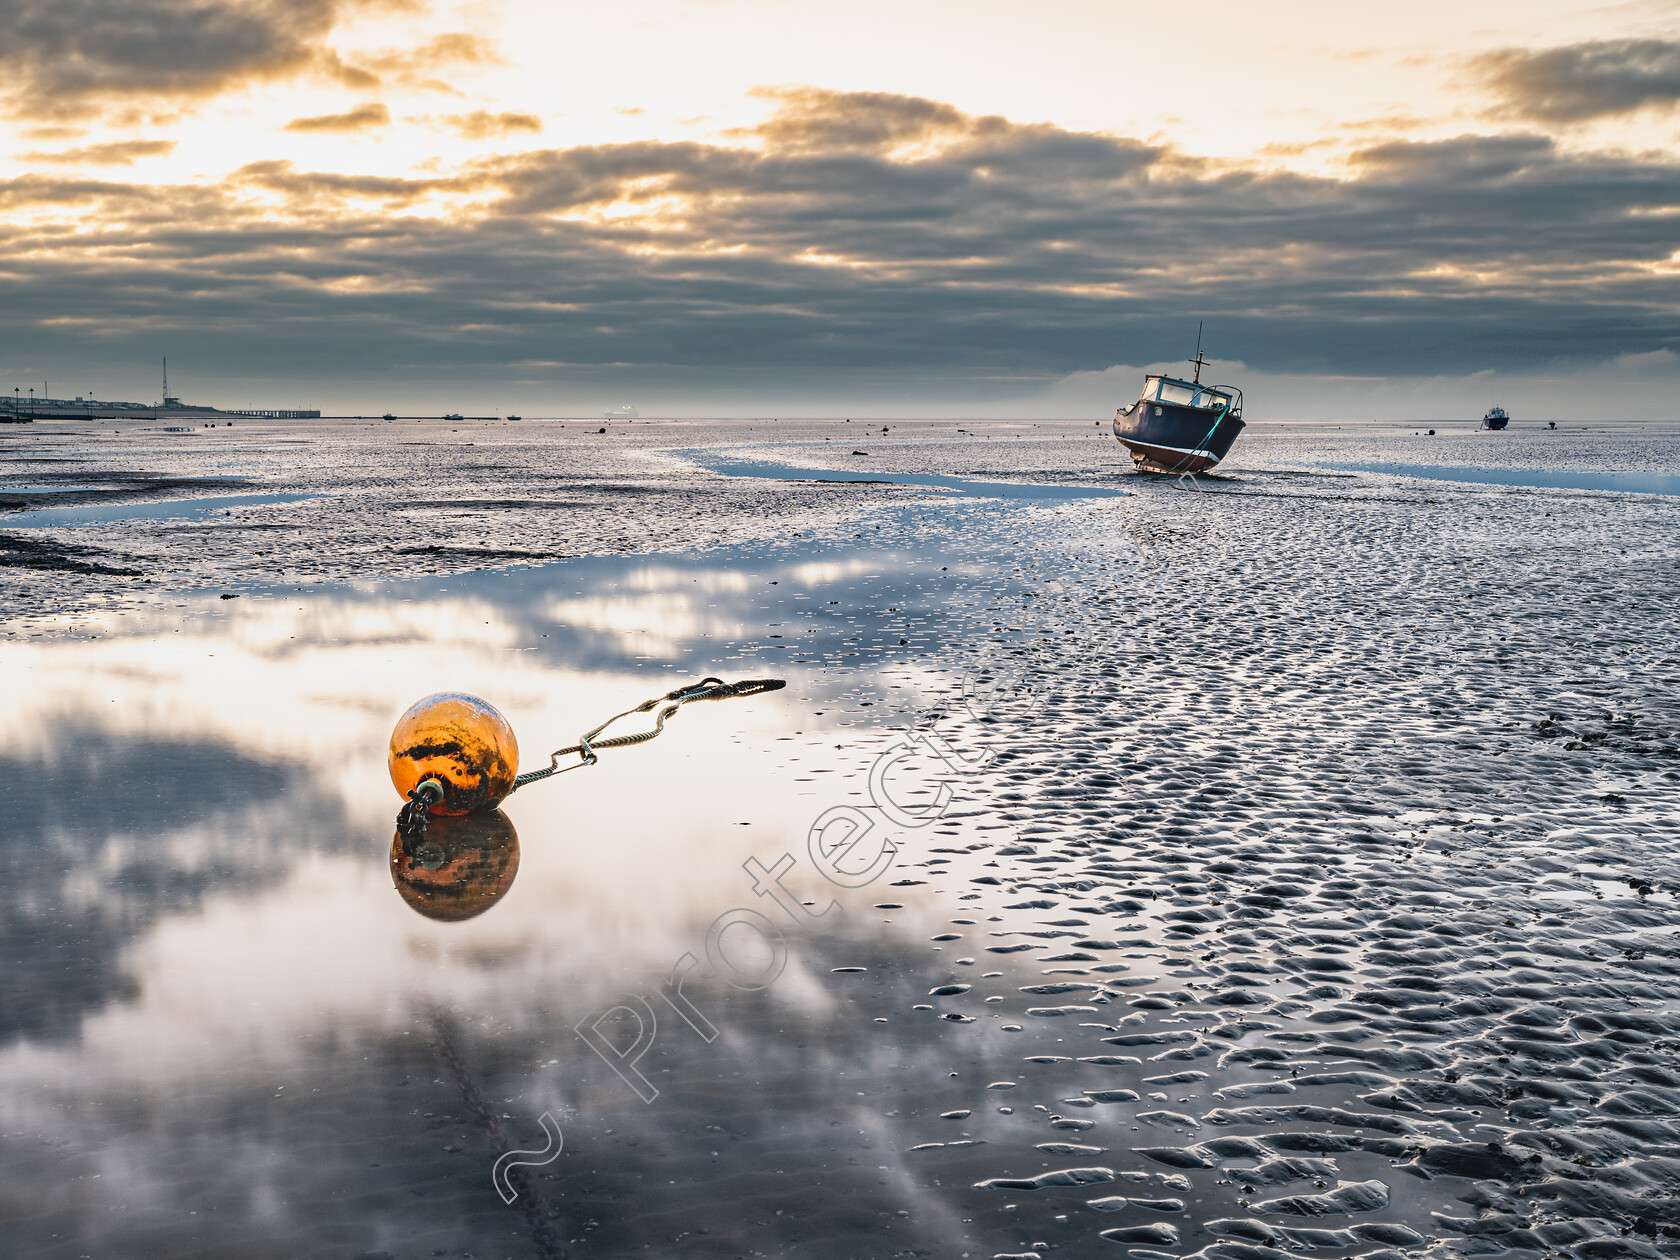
[0,0,400,118]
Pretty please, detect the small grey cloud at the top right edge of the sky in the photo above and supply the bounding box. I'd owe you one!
[1468,39,1680,123]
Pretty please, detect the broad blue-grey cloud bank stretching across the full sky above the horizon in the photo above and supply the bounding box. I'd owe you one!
[0,89,1680,396]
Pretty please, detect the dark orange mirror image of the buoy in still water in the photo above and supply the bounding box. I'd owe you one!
[391,810,519,922]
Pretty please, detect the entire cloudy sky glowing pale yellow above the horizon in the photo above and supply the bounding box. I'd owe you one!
[0,0,1680,420]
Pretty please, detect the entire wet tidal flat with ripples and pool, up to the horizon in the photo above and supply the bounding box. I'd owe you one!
[0,422,1680,1260]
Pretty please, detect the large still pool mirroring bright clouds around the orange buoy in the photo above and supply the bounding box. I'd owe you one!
[0,514,1075,1257]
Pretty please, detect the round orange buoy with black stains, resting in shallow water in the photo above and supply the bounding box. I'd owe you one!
[390,690,519,815]
